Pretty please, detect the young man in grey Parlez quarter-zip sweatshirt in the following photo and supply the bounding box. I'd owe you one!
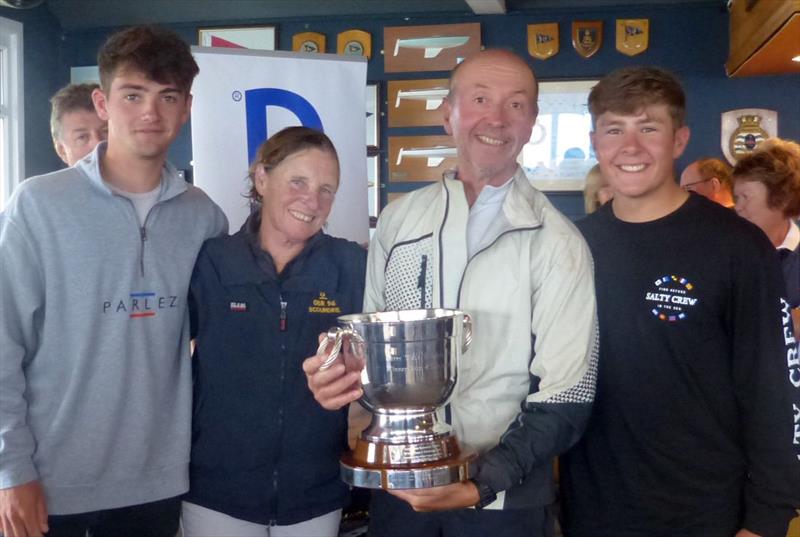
[0,27,228,537]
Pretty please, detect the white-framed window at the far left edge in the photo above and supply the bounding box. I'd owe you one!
[0,17,25,211]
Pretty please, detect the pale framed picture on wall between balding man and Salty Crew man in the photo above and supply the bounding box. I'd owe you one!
[519,81,597,190]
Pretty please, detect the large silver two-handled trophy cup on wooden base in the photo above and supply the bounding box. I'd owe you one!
[320,309,475,489]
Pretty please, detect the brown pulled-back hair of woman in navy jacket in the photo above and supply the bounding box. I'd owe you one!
[247,127,339,203]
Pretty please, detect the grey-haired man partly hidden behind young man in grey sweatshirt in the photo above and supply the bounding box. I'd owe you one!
[50,84,108,166]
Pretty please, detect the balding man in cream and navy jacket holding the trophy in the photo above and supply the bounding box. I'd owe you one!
[304,50,597,536]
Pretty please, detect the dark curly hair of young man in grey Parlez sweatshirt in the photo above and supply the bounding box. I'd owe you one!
[97,25,200,95]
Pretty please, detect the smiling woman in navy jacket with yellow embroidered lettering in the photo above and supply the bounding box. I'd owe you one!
[183,127,366,537]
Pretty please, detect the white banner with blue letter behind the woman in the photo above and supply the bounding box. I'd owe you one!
[192,47,369,244]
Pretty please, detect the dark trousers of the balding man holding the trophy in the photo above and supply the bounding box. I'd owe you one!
[367,491,554,537]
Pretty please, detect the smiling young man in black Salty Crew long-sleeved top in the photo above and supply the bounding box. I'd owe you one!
[561,67,800,537]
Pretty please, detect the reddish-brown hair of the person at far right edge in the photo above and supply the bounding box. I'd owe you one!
[733,138,800,218]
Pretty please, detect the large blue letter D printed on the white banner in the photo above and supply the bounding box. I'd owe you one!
[244,88,323,162]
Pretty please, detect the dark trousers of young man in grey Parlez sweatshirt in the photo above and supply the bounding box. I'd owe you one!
[47,497,181,537]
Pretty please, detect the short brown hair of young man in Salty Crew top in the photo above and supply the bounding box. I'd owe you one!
[589,67,686,129]
